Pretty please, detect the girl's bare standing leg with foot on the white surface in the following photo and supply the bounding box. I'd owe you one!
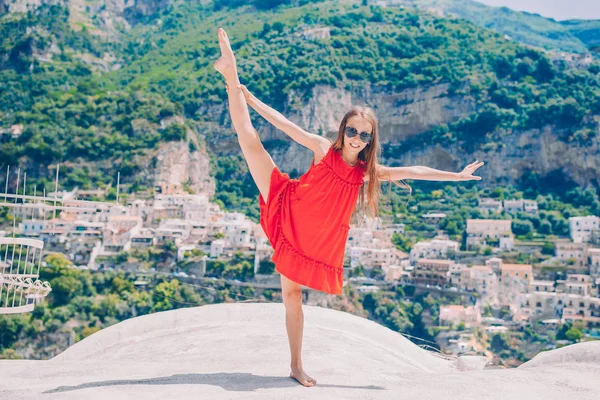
[281,275,317,386]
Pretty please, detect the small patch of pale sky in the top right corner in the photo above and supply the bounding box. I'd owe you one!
[475,0,600,21]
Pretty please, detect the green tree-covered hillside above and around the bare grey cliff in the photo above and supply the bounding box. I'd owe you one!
[0,1,600,211]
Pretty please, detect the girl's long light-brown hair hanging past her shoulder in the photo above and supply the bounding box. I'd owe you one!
[332,106,412,222]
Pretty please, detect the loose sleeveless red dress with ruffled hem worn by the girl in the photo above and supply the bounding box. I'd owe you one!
[259,146,366,294]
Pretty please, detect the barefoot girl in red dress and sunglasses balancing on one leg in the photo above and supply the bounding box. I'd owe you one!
[214,29,483,386]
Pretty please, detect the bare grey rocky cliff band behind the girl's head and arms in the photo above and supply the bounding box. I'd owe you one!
[206,84,600,185]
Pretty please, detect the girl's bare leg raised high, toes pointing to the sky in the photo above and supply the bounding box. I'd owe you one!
[214,28,275,202]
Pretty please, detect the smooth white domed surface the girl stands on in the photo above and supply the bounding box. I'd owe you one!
[0,303,600,400]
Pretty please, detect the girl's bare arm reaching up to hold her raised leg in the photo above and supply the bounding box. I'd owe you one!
[239,85,331,154]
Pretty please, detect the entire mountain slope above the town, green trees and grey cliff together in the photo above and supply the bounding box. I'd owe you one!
[0,1,600,209]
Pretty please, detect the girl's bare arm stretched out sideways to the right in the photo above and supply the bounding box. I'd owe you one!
[380,161,483,181]
